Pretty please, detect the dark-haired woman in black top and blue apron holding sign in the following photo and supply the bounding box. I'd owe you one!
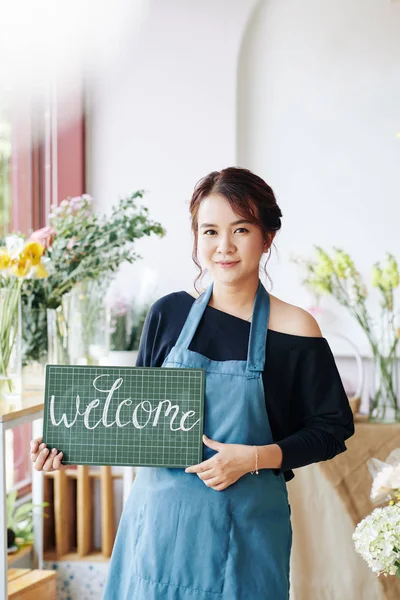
[31,168,354,600]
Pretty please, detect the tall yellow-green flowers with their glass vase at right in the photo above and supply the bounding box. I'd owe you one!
[292,246,400,421]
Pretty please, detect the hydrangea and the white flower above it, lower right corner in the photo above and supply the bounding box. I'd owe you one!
[353,448,400,578]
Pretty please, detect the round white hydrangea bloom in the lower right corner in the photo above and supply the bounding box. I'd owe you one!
[353,504,400,575]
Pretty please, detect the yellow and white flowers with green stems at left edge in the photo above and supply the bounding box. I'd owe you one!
[0,235,49,393]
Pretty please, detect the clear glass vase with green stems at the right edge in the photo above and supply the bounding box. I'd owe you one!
[369,315,400,423]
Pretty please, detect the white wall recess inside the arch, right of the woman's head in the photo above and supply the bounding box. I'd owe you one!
[238,0,400,354]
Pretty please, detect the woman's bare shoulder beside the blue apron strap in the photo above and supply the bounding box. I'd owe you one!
[269,294,322,337]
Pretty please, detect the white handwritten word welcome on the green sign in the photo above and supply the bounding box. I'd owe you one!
[50,374,200,431]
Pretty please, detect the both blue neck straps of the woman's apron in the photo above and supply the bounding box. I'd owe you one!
[176,281,270,372]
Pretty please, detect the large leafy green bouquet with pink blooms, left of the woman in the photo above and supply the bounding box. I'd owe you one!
[23,190,165,362]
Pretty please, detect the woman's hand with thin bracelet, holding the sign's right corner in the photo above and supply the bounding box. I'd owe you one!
[185,435,255,492]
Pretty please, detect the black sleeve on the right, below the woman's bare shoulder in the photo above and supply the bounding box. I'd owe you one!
[277,342,354,472]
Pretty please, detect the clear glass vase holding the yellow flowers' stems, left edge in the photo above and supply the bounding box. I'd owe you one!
[0,280,22,405]
